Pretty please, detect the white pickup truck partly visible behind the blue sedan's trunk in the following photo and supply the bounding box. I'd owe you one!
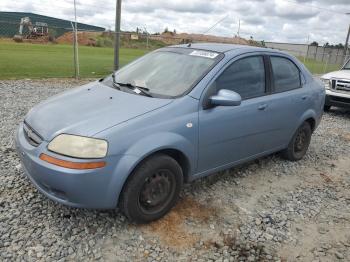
[321,59,350,111]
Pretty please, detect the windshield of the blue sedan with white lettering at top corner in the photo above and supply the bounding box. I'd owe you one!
[102,48,220,97]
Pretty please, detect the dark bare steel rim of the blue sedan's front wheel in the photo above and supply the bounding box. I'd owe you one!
[139,170,174,213]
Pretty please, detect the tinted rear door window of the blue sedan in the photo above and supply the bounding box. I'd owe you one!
[271,56,301,93]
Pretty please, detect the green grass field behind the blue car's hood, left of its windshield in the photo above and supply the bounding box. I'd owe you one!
[0,40,148,79]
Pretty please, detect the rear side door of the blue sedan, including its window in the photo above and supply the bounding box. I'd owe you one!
[265,55,310,150]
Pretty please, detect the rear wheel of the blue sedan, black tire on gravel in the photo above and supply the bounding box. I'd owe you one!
[281,122,312,161]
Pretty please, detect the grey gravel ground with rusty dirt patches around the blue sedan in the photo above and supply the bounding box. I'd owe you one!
[0,80,350,261]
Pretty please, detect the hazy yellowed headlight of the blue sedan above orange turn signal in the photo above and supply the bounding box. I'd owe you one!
[48,134,108,158]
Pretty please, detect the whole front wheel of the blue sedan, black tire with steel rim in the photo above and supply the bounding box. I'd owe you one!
[120,154,183,224]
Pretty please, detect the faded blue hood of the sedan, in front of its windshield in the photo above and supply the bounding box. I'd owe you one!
[25,82,172,141]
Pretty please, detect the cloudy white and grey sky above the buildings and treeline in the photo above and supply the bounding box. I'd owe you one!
[0,0,350,44]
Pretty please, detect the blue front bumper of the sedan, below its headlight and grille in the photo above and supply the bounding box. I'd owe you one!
[15,124,122,209]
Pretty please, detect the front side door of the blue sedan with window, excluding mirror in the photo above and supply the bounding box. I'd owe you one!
[197,55,269,173]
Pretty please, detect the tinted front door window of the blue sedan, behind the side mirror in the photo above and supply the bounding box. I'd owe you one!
[216,56,265,99]
